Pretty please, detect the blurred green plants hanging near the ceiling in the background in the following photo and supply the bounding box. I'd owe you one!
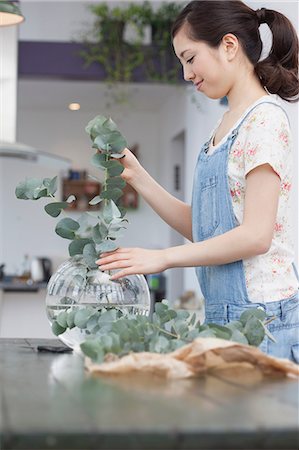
[80,1,183,85]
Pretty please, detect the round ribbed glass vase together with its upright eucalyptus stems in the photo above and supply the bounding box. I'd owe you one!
[16,116,152,347]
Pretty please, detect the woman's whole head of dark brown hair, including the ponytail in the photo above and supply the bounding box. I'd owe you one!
[172,0,299,102]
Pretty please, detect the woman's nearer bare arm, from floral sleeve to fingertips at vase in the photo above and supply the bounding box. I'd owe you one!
[98,164,280,279]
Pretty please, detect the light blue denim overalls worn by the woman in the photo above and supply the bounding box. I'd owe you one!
[192,101,299,363]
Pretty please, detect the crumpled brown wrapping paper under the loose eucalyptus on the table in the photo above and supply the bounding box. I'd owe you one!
[85,337,299,379]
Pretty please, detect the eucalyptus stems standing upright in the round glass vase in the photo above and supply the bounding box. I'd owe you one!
[15,115,127,270]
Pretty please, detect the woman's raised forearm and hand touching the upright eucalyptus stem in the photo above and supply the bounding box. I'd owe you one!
[120,149,192,241]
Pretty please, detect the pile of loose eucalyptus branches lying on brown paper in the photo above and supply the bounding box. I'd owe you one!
[52,301,274,362]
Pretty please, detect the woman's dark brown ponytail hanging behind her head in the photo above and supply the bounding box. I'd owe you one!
[255,8,299,102]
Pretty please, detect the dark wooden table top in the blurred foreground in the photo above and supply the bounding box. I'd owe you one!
[0,339,299,450]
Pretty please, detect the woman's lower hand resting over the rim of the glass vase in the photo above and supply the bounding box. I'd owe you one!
[96,248,167,280]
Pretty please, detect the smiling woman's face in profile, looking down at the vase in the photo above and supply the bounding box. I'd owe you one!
[173,27,231,99]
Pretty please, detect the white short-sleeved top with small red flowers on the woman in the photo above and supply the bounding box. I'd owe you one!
[208,95,298,302]
